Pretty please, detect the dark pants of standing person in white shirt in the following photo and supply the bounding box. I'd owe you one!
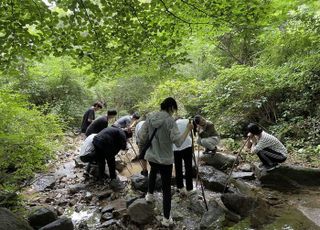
[174,147,193,191]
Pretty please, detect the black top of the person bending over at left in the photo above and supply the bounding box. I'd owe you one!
[92,127,127,156]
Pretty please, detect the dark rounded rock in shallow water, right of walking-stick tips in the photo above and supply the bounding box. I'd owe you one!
[221,193,270,217]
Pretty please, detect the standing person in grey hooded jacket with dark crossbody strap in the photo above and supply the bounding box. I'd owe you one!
[139,97,193,226]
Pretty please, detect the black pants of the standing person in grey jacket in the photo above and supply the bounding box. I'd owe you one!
[148,162,172,219]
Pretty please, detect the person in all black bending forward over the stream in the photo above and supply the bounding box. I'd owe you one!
[92,127,132,183]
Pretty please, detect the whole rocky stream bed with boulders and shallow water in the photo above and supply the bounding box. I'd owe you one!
[0,136,320,230]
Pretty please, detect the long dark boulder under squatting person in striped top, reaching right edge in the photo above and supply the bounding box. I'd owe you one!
[255,165,320,189]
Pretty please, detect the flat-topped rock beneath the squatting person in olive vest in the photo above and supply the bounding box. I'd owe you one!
[200,152,237,170]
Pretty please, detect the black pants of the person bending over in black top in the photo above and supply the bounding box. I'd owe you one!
[95,146,117,179]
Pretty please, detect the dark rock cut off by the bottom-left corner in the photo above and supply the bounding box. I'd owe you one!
[0,208,32,230]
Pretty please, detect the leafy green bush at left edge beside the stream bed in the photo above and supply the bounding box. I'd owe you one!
[0,90,62,189]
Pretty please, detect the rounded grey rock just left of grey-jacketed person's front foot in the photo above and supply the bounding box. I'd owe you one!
[128,199,154,224]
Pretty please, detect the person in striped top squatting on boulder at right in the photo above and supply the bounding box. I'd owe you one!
[247,123,287,171]
